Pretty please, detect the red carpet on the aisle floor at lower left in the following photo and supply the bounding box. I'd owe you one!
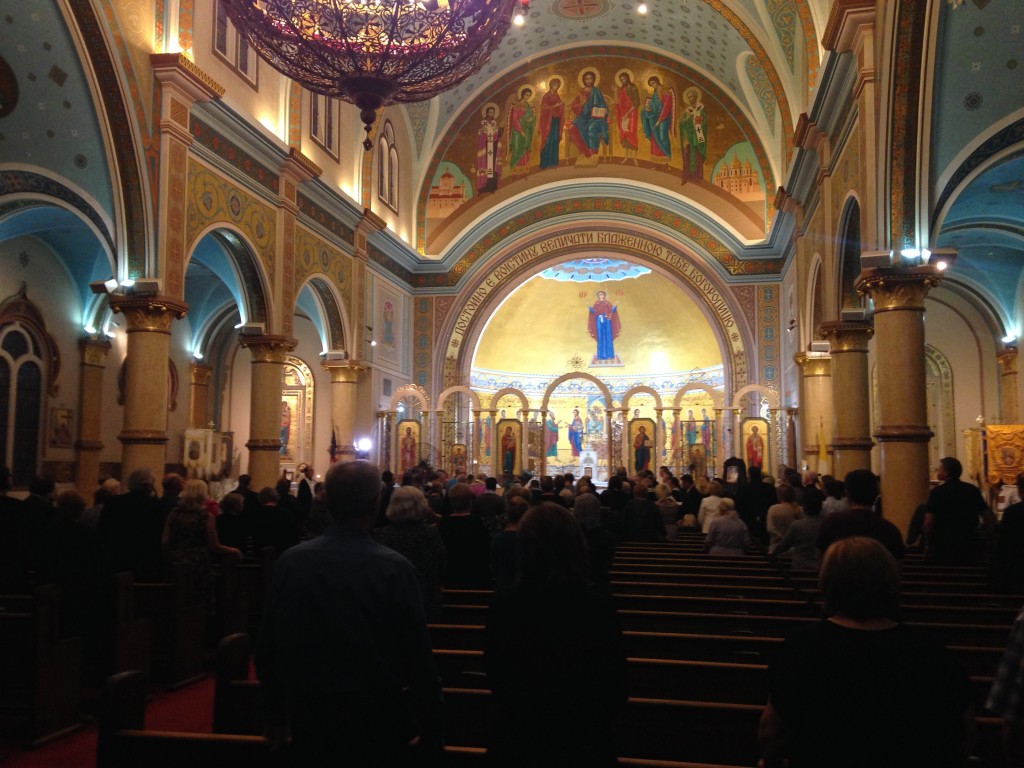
[0,677,213,768]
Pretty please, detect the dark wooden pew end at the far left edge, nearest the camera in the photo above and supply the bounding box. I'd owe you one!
[0,586,82,746]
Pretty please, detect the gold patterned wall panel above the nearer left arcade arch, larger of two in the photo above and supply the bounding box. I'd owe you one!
[185,160,276,274]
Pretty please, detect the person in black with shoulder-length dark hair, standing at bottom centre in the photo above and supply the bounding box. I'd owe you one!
[483,503,628,768]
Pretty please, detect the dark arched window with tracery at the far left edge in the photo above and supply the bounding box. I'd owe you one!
[0,322,44,485]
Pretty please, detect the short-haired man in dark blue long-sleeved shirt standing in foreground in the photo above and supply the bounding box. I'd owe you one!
[256,462,442,768]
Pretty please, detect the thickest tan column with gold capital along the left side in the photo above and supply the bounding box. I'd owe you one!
[111,295,188,480]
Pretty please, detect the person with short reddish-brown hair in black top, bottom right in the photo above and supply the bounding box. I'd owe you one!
[759,536,974,768]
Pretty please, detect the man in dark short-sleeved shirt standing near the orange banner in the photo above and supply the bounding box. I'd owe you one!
[925,456,995,563]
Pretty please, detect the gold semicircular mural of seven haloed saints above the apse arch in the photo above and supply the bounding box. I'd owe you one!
[420,55,775,253]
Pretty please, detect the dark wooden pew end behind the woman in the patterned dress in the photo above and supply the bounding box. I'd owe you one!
[135,569,207,690]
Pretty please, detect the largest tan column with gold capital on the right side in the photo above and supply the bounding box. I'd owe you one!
[857,264,942,534]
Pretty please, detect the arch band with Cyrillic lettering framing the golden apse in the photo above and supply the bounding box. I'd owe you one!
[431,221,758,403]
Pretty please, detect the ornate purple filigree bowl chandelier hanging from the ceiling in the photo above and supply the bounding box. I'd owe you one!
[221,0,516,151]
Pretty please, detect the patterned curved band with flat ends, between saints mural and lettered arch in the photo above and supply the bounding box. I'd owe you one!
[410,198,782,288]
